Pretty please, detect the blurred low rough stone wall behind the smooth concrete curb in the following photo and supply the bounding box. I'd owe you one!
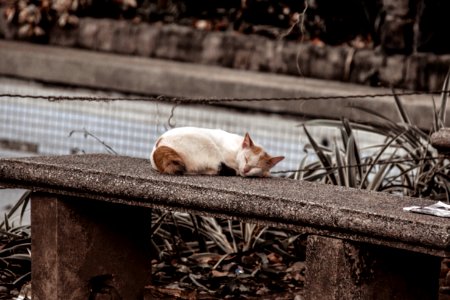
[44,18,450,90]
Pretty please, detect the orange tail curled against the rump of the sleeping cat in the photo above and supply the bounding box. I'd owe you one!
[153,146,186,175]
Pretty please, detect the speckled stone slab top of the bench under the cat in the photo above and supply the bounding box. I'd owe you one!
[0,154,450,256]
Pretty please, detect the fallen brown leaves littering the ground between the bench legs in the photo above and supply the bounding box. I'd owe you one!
[146,251,305,299]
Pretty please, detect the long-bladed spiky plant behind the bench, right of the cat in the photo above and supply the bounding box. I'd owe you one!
[294,75,450,201]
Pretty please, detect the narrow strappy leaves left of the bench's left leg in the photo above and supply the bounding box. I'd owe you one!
[0,192,31,300]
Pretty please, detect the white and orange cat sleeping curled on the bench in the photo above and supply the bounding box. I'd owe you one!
[150,127,284,177]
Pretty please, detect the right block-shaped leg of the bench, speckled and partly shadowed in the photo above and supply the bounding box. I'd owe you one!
[305,236,440,300]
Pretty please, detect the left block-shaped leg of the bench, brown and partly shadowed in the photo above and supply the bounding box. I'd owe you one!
[31,194,151,300]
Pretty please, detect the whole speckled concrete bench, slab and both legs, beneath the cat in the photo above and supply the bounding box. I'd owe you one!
[0,154,450,300]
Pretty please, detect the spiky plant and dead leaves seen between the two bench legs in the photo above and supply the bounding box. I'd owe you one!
[151,212,305,299]
